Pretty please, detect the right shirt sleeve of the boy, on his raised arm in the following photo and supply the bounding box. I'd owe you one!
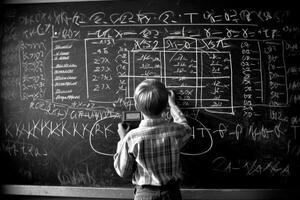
[170,105,192,147]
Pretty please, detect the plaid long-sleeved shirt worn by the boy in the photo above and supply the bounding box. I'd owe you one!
[114,106,191,186]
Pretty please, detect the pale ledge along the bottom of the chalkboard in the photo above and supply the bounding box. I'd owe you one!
[2,185,300,200]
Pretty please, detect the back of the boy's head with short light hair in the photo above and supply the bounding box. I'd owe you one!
[134,79,169,117]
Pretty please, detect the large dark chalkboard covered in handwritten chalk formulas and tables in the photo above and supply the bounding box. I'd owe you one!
[0,1,300,188]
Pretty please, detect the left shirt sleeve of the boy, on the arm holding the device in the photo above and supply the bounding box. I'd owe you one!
[114,137,135,178]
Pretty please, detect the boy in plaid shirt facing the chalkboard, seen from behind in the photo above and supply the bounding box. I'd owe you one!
[114,79,191,200]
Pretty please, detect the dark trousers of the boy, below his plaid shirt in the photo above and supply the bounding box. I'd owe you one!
[134,183,182,200]
